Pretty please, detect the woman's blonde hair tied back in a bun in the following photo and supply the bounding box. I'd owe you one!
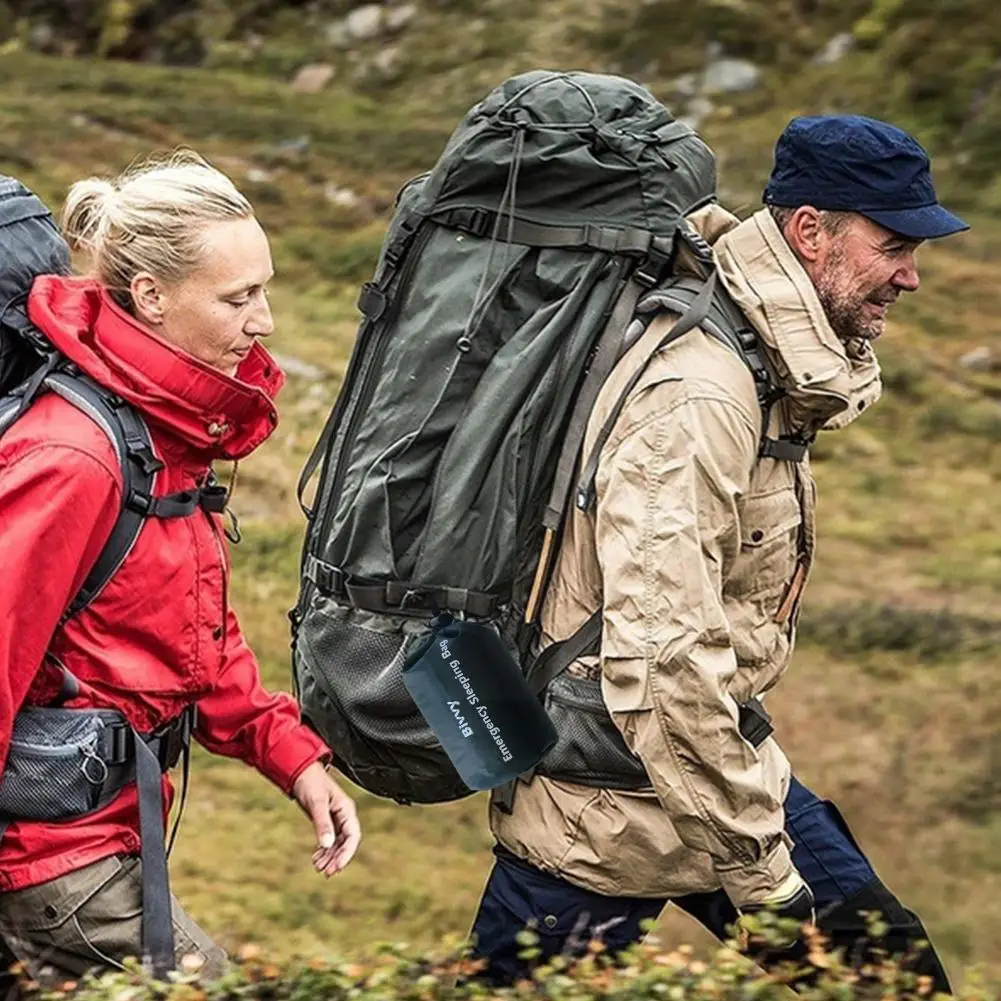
[62,149,253,307]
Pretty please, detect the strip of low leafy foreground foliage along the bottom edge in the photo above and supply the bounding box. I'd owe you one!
[17,914,993,1001]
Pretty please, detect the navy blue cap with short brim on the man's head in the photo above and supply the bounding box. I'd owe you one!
[764,115,970,240]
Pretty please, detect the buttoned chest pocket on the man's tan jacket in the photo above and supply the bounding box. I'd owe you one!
[724,485,805,608]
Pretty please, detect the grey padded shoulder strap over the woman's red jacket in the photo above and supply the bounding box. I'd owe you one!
[45,369,163,622]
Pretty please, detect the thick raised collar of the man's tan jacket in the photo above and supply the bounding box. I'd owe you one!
[708,209,882,429]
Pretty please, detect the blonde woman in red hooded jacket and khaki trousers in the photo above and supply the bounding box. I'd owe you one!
[0,154,360,981]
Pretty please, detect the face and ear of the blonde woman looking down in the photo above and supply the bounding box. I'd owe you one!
[130,219,274,375]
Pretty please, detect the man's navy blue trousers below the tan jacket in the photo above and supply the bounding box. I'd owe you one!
[472,779,936,984]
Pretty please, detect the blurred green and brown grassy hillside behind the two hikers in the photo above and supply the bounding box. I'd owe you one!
[0,0,1001,974]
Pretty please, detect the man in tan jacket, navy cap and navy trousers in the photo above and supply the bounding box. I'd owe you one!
[473,116,966,990]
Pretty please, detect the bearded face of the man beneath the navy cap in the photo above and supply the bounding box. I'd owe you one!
[807,214,921,342]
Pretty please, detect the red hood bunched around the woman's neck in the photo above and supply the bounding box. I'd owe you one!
[28,275,284,461]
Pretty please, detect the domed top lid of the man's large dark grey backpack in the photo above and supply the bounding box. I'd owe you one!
[418,70,716,237]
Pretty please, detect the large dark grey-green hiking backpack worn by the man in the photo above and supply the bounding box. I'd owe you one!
[290,71,796,803]
